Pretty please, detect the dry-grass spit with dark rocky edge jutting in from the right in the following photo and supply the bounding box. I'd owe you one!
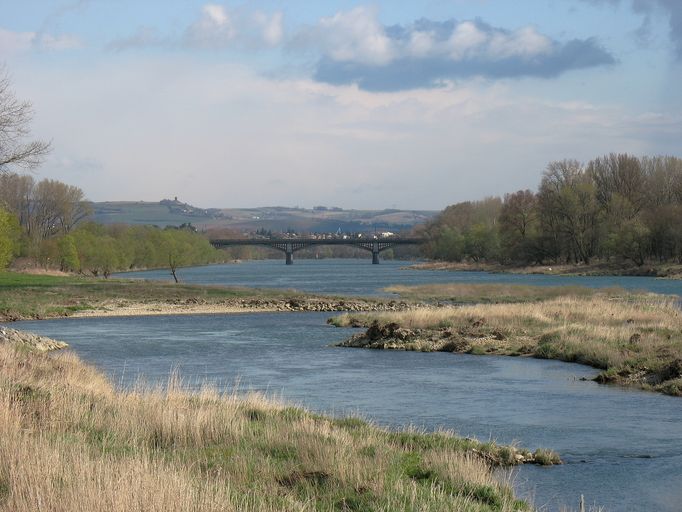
[330,293,682,396]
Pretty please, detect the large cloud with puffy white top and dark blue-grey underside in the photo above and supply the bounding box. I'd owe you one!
[300,11,616,91]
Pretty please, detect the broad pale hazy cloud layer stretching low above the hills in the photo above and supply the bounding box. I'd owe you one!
[13,56,682,209]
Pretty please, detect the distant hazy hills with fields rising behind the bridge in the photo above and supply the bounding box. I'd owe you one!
[92,198,438,233]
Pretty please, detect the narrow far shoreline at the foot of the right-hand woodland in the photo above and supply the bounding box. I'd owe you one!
[407,261,682,279]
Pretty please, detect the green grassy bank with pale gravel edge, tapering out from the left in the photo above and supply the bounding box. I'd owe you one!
[0,272,415,322]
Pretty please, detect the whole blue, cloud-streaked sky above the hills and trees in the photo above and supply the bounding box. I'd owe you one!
[0,0,682,210]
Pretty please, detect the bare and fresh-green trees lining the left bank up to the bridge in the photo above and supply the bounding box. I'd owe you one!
[0,172,223,281]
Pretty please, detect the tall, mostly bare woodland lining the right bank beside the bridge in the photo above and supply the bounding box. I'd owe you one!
[423,154,682,266]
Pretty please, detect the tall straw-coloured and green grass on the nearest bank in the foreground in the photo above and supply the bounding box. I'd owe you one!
[0,344,551,512]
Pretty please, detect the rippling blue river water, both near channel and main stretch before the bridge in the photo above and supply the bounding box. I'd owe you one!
[11,260,682,512]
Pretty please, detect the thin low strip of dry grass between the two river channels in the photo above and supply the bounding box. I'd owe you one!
[384,283,612,304]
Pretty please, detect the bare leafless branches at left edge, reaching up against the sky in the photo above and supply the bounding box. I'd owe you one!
[0,69,50,174]
